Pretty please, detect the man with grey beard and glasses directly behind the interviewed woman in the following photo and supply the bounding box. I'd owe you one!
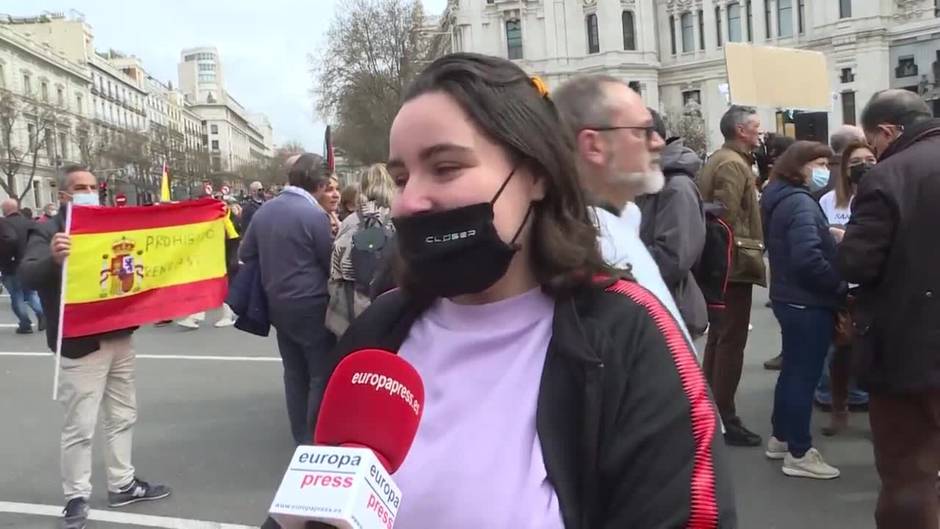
[552,75,691,347]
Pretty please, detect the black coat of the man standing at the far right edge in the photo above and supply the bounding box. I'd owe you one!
[838,119,940,393]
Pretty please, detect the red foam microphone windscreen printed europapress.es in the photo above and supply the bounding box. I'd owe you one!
[314,349,424,473]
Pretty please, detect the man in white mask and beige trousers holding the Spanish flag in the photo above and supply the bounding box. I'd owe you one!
[19,166,170,529]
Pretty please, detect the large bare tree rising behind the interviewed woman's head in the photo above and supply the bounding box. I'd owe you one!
[310,0,429,163]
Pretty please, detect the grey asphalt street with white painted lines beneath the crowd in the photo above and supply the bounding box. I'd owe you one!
[0,290,878,529]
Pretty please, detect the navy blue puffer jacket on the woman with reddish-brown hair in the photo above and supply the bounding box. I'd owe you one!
[761,180,846,309]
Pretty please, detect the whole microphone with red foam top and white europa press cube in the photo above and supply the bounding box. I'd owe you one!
[270,349,424,529]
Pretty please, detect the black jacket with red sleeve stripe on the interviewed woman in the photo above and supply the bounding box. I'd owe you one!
[333,274,737,529]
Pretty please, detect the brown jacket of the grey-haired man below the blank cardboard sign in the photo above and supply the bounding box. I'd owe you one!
[697,143,767,286]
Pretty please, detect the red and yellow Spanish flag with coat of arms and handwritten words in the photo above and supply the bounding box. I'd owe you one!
[61,198,228,338]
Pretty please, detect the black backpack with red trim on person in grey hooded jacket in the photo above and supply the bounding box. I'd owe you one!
[692,203,734,309]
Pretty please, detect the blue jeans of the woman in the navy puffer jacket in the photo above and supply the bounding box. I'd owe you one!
[771,301,835,457]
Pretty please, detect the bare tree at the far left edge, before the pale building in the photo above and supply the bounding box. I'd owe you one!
[0,90,70,202]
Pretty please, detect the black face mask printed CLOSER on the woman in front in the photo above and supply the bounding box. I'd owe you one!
[392,169,532,298]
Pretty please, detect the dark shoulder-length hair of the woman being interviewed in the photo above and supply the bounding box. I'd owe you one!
[401,53,609,295]
